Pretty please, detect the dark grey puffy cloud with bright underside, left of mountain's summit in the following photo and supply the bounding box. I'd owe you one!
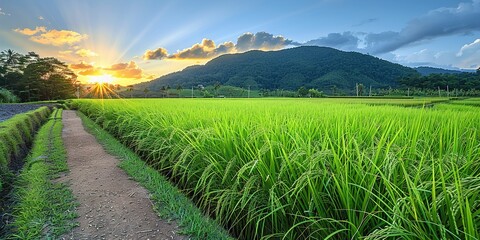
[235,32,292,52]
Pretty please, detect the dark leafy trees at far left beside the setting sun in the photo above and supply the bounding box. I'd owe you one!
[0,49,79,102]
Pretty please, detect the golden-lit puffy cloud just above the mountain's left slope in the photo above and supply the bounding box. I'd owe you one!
[168,38,235,59]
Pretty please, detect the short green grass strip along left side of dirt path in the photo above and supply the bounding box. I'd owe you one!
[7,109,77,239]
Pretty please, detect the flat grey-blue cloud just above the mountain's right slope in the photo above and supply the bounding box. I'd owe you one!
[302,32,360,50]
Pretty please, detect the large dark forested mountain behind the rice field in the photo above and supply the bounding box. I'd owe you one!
[139,46,418,92]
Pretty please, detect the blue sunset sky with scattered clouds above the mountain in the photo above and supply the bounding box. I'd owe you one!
[0,0,480,85]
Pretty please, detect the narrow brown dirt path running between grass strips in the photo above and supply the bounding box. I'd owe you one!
[62,111,186,239]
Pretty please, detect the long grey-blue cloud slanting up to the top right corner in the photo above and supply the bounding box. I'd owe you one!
[365,0,480,53]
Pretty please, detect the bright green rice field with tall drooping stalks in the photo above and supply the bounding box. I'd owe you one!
[72,99,480,239]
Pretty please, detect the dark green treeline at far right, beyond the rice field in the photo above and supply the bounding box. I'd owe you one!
[399,68,480,91]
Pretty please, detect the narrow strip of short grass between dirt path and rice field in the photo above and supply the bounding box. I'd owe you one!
[79,110,231,239]
